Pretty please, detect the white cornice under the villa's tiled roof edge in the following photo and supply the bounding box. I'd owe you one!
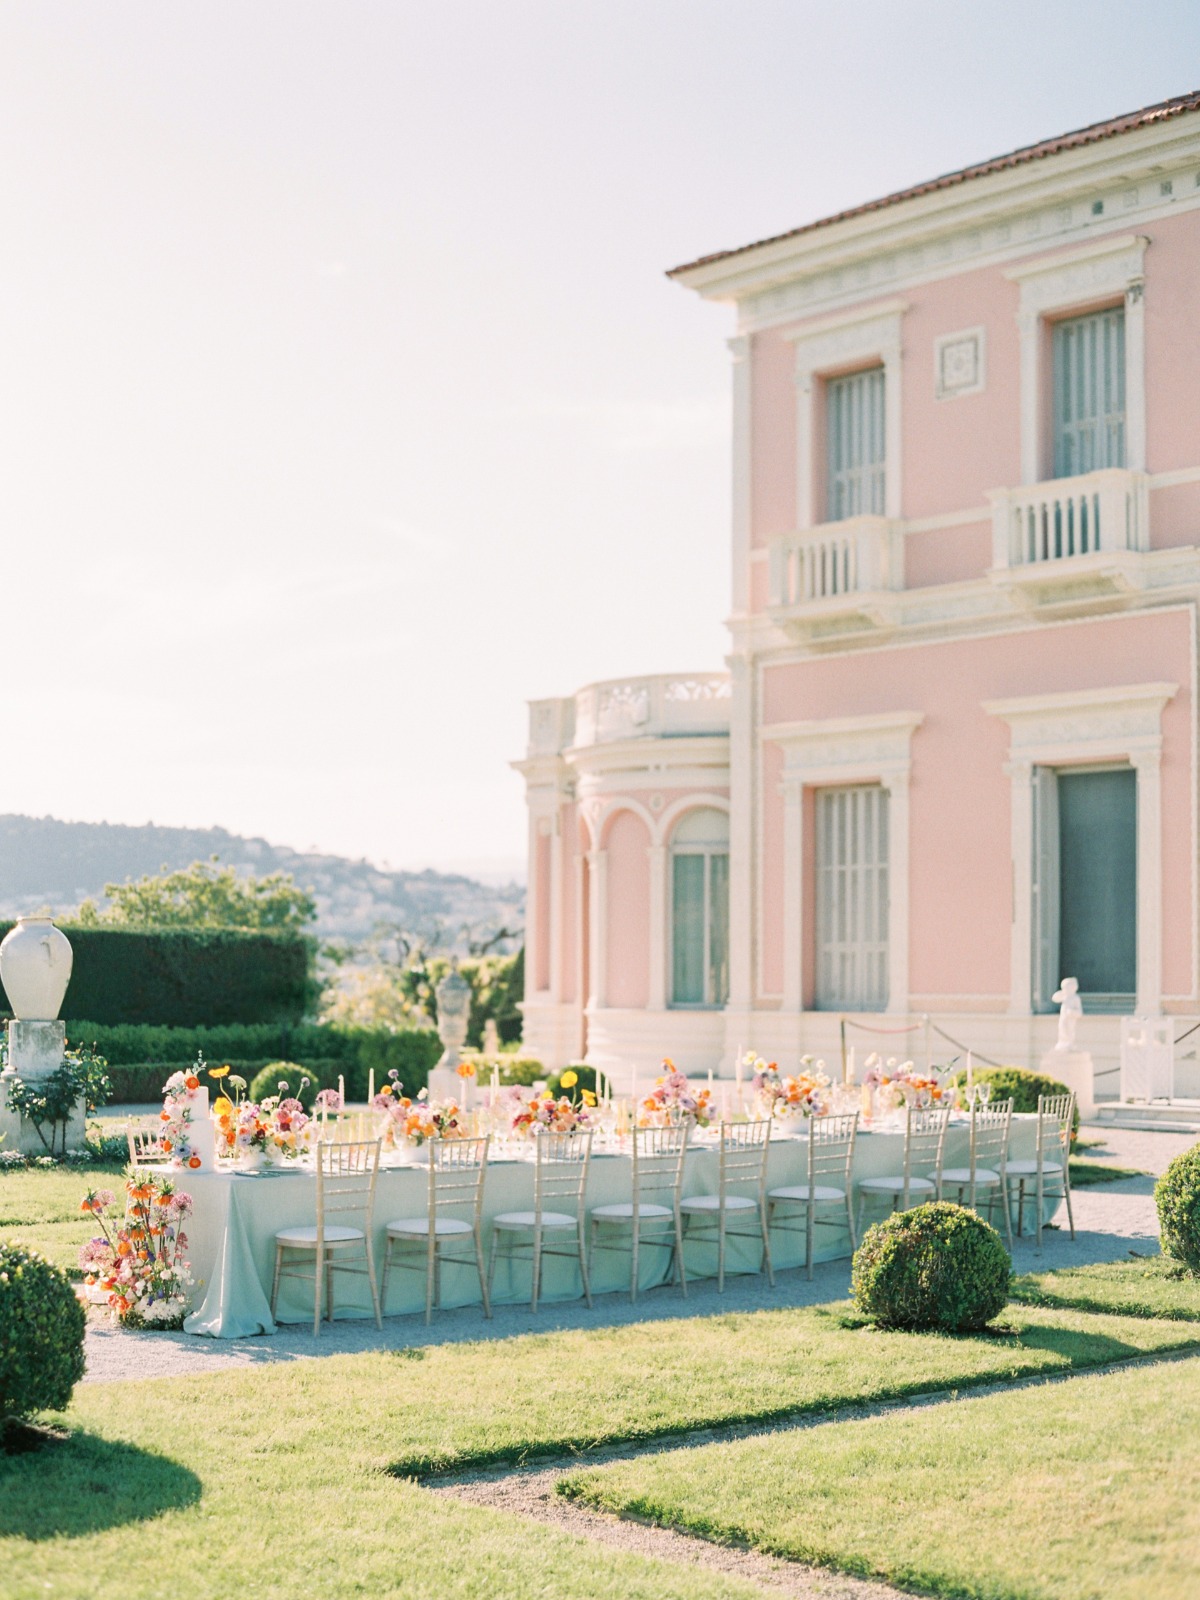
[677,115,1200,333]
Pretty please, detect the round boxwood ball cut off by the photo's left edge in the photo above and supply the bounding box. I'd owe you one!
[0,1242,86,1422]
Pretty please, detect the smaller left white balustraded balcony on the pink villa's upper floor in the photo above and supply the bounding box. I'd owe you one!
[770,517,904,640]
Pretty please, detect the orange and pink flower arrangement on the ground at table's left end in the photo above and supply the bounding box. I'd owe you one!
[78,1168,192,1328]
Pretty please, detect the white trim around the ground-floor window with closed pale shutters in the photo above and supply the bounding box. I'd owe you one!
[763,710,925,1016]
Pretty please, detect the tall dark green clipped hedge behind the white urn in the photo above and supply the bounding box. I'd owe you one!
[0,922,315,1027]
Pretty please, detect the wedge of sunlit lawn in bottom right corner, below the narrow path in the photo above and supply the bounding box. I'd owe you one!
[562,1358,1200,1600]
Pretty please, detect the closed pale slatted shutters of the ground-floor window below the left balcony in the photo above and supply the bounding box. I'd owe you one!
[814,784,888,1011]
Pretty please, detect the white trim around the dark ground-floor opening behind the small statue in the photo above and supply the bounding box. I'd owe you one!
[982,683,1179,1016]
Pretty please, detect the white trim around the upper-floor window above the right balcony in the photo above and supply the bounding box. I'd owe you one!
[1005,234,1149,483]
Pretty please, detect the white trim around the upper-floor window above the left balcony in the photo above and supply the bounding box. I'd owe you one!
[784,301,907,530]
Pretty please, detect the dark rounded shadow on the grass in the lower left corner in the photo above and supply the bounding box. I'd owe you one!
[0,1426,202,1536]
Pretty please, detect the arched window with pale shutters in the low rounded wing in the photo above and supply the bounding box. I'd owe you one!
[670,806,730,1006]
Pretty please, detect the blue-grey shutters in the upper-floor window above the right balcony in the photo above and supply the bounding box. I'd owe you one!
[1053,306,1125,478]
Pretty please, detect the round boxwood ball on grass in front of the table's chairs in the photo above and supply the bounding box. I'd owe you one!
[851,1200,1013,1333]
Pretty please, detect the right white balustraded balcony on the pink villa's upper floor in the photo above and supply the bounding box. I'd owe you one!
[987,467,1150,610]
